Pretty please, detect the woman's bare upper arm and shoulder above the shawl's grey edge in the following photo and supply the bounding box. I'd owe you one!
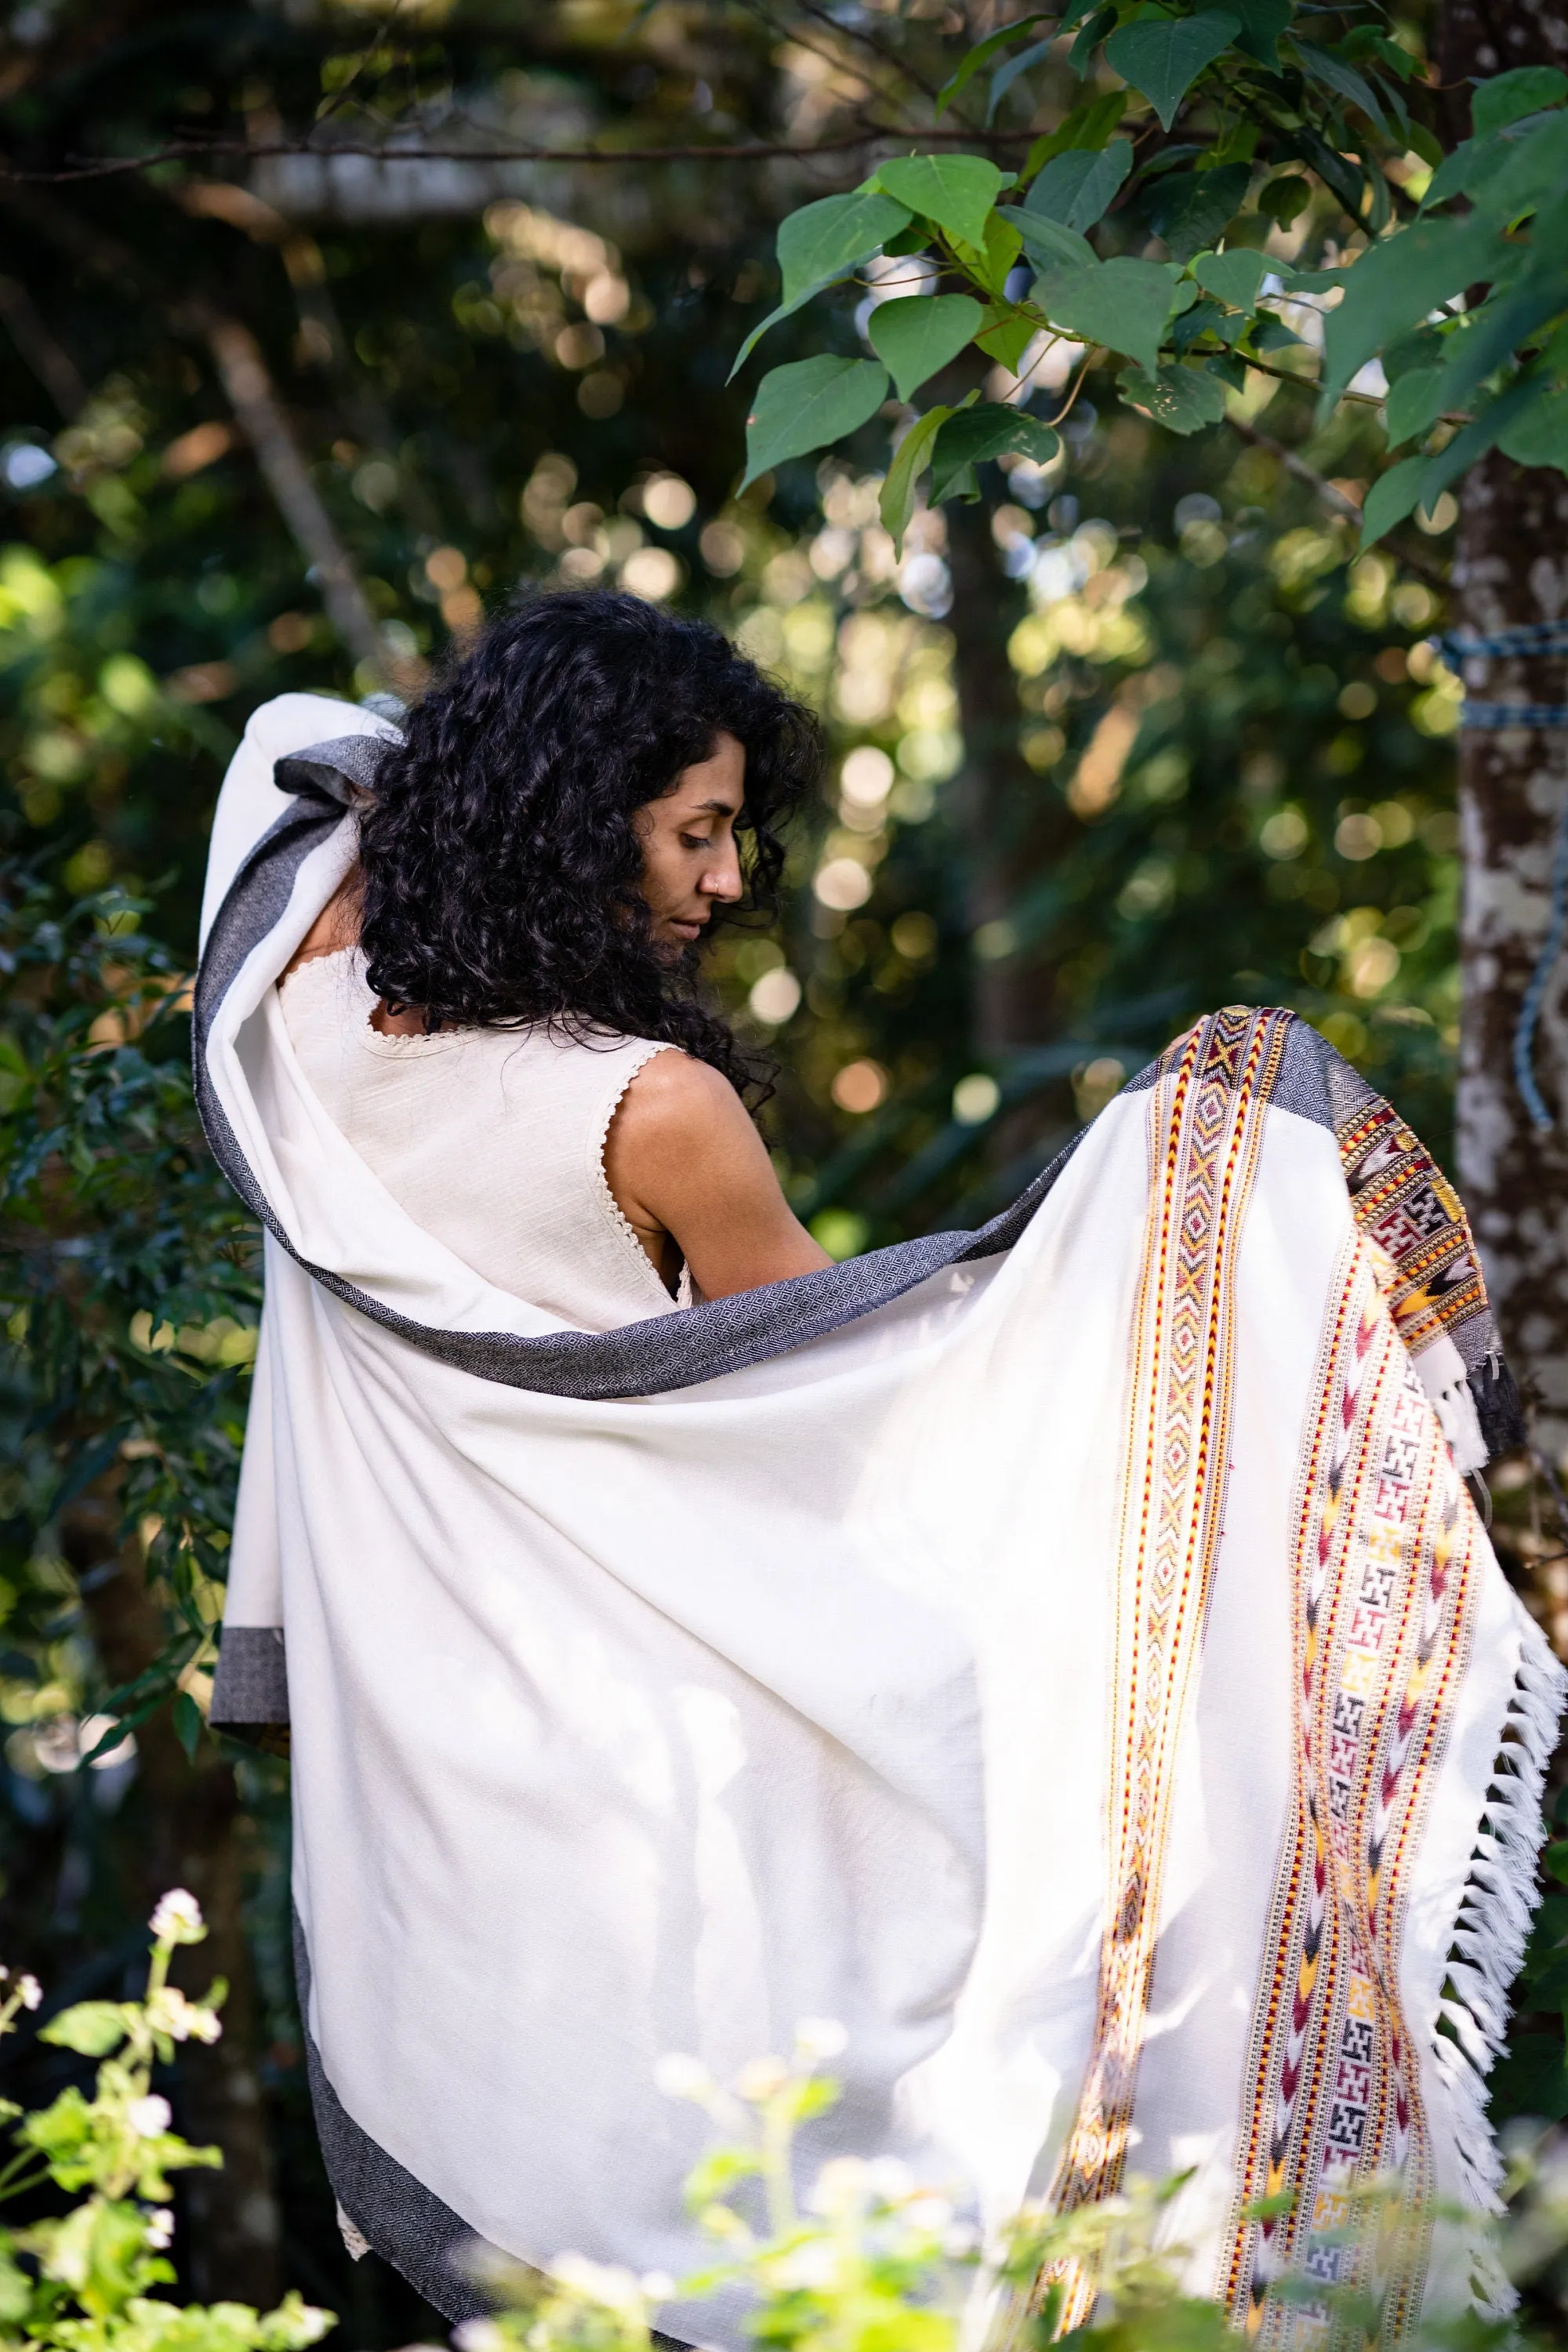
[604,1051,832,1298]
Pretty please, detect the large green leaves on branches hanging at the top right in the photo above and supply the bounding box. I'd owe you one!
[743,0,1568,546]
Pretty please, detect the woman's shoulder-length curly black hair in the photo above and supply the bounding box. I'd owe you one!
[360,590,822,1094]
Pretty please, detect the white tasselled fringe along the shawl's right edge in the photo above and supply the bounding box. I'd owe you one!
[1432,1618,1568,2319]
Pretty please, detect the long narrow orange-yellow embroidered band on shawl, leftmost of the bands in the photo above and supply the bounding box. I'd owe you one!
[1032,1009,1290,2328]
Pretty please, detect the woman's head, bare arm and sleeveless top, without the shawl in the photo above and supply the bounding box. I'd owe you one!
[272,595,829,1331]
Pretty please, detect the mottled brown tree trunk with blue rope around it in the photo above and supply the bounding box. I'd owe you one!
[1439,0,1568,1470]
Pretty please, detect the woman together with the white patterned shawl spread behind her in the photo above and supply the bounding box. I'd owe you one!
[205,597,1563,2343]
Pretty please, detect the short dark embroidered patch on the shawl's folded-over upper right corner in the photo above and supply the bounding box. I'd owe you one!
[1335,1091,1495,1362]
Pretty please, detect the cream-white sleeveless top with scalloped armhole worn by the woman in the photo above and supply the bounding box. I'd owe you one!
[280,948,691,1331]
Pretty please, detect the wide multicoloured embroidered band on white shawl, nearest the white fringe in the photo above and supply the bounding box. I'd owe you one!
[1222,1247,1476,2352]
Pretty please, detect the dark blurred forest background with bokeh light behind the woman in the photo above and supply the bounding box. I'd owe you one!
[0,0,1568,2347]
